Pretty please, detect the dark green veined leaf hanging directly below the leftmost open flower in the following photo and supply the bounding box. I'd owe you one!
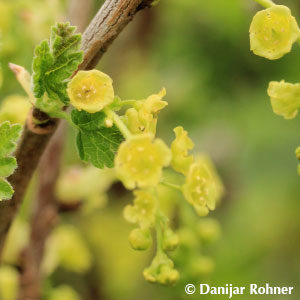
[72,109,124,169]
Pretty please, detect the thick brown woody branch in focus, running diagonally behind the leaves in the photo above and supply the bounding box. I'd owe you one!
[0,0,155,253]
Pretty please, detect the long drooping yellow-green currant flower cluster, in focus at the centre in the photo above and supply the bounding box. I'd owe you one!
[63,70,223,284]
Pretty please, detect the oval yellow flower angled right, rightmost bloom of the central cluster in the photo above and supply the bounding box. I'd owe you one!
[183,157,223,216]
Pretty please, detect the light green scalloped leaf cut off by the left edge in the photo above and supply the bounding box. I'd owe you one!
[0,122,22,200]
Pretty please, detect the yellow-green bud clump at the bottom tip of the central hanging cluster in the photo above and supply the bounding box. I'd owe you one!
[143,252,179,285]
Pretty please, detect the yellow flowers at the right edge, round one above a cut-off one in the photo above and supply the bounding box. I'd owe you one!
[250,1,300,175]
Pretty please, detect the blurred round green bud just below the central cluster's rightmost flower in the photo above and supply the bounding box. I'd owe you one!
[197,218,221,243]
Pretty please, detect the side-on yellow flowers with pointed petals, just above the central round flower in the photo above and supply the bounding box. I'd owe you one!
[125,88,168,134]
